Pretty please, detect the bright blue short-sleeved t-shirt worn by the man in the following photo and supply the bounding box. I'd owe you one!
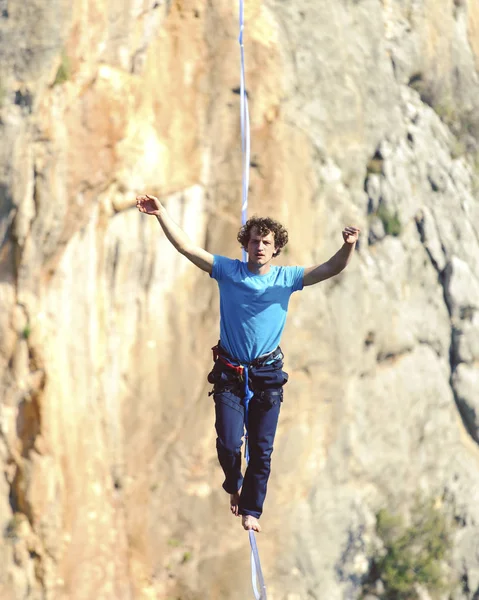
[211,254,304,363]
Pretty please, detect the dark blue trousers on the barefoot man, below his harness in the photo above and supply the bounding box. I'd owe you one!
[209,355,288,518]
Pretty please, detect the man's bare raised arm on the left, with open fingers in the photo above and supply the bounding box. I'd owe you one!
[136,194,213,274]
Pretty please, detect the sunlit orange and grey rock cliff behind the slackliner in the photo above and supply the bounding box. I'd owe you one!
[0,0,479,600]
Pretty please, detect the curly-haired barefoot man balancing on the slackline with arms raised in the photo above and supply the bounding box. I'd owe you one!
[136,195,359,531]
